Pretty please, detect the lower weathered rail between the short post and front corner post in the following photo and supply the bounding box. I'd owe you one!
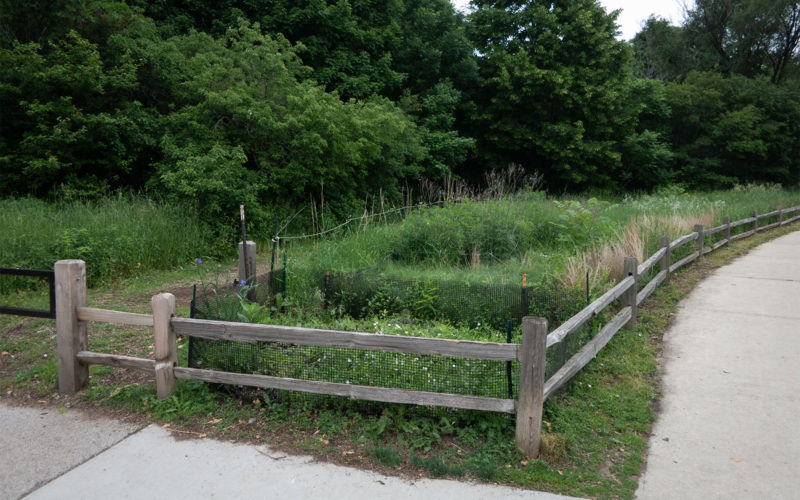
[174,367,516,413]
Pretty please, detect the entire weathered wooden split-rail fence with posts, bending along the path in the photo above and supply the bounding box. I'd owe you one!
[55,205,800,458]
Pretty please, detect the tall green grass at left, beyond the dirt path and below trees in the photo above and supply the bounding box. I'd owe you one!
[0,197,219,286]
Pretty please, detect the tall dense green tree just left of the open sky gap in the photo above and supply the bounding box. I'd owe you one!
[469,0,630,190]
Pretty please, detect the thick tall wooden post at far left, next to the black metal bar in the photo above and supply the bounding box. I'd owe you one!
[55,260,89,392]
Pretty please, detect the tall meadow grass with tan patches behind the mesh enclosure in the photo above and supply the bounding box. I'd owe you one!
[274,185,800,297]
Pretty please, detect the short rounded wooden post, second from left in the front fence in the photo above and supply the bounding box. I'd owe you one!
[151,293,178,399]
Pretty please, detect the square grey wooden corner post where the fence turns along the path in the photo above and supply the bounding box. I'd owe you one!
[516,316,547,458]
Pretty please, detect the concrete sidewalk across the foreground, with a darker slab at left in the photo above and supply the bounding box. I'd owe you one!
[0,404,568,500]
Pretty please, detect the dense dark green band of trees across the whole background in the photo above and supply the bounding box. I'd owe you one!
[0,0,800,236]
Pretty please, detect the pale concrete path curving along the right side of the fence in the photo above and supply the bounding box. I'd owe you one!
[637,231,800,500]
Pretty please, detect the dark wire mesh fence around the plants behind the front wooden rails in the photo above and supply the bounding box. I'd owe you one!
[189,270,591,398]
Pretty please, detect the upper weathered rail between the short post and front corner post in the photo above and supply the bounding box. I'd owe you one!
[172,318,519,361]
